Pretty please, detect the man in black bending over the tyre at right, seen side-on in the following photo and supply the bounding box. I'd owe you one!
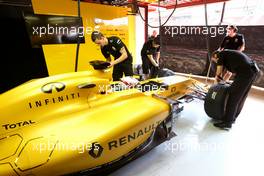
[212,50,259,129]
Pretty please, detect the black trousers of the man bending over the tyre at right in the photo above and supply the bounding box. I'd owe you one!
[223,66,258,123]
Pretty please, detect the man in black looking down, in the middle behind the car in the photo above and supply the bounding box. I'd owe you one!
[141,35,160,79]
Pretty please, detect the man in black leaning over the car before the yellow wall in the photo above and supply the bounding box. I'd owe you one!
[91,31,133,81]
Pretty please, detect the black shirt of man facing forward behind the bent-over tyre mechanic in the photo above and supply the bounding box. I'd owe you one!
[221,34,245,50]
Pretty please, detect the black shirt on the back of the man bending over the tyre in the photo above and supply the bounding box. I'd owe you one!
[217,50,253,75]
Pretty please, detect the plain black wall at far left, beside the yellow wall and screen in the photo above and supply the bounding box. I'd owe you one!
[0,0,48,93]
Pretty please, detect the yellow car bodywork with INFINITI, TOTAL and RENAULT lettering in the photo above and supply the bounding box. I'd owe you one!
[0,71,200,176]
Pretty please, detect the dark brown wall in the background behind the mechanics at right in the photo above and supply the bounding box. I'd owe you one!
[161,26,264,87]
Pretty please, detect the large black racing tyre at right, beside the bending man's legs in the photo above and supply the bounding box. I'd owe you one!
[204,83,230,120]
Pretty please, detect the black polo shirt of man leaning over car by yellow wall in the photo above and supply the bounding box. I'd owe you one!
[101,36,132,64]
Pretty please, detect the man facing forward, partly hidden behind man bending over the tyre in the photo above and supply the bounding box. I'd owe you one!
[219,25,245,81]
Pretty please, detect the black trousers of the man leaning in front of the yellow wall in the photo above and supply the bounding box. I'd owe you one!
[112,63,133,81]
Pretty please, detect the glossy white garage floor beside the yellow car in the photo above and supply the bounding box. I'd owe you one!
[111,92,264,176]
